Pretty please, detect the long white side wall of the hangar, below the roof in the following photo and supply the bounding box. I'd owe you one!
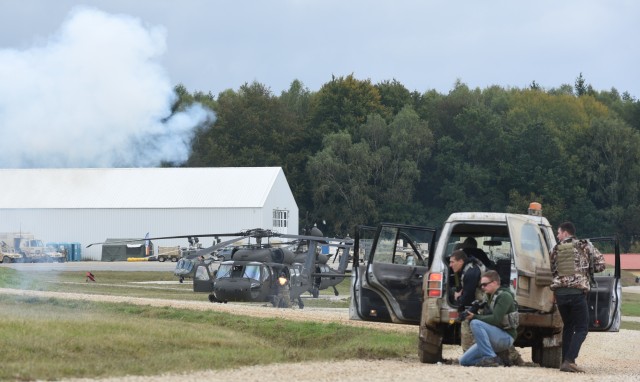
[0,208,278,260]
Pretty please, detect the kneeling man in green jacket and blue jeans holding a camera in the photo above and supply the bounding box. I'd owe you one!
[460,271,518,366]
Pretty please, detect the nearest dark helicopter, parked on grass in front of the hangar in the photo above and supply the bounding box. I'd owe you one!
[193,228,353,308]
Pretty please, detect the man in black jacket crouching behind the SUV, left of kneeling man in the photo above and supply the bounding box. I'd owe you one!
[449,250,482,351]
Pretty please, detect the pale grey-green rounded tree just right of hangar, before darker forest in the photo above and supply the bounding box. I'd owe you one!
[308,107,433,232]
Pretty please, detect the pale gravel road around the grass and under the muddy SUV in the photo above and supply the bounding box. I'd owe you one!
[0,288,640,382]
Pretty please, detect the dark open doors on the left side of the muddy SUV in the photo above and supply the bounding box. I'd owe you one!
[350,223,436,324]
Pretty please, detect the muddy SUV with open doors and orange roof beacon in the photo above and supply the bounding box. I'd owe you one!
[349,204,621,368]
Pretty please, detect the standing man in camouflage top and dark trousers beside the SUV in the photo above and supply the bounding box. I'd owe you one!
[550,222,605,373]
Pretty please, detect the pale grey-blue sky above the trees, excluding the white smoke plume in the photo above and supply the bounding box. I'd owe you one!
[0,0,640,98]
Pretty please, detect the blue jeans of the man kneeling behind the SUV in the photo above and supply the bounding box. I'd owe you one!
[460,320,513,366]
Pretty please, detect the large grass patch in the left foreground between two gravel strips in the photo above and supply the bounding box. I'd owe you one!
[0,295,416,380]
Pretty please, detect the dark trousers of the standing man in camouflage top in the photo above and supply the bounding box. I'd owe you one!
[556,293,589,363]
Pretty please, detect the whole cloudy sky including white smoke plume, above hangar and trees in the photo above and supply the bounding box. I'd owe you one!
[0,0,640,168]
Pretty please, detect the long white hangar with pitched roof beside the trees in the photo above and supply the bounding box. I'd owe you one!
[0,167,299,260]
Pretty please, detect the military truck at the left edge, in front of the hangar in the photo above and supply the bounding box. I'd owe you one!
[0,232,65,263]
